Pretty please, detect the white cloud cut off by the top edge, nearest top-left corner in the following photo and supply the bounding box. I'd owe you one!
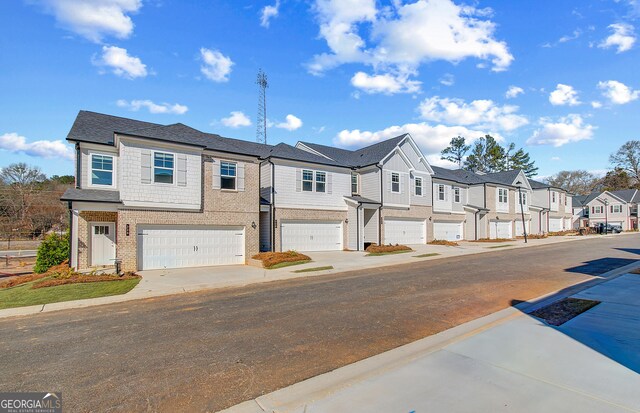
[35,0,142,43]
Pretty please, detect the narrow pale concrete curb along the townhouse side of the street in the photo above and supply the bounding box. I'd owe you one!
[0,232,638,319]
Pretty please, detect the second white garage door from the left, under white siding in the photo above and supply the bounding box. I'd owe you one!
[281,221,342,251]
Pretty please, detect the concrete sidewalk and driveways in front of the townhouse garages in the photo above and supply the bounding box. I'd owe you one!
[0,233,637,318]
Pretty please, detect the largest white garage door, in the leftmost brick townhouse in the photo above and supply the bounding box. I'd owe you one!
[138,225,245,270]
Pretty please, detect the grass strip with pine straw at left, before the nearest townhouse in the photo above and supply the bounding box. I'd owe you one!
[0,278,140,309]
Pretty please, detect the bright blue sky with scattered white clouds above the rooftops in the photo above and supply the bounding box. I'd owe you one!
[0,0,640,176]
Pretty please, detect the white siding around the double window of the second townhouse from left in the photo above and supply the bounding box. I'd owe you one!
[274,160,351,211]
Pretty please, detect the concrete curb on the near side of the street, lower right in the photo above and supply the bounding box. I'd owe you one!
[219,260,640,413]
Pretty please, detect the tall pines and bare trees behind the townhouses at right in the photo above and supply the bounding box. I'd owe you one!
[441,135,640,195]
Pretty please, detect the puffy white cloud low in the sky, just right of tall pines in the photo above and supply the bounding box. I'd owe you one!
[527,114,596,147]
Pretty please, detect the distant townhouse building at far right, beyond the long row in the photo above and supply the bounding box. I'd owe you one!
[573,189,640,231]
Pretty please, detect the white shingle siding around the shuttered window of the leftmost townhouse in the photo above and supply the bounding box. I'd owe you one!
[118,139,202,209]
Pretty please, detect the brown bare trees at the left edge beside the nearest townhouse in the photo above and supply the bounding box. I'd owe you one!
[0,163,75,238]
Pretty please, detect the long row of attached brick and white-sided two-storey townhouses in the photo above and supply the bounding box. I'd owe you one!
[62,111,572,271]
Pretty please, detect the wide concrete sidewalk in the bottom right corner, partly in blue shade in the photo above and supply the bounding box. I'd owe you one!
[225,264,640,413]
